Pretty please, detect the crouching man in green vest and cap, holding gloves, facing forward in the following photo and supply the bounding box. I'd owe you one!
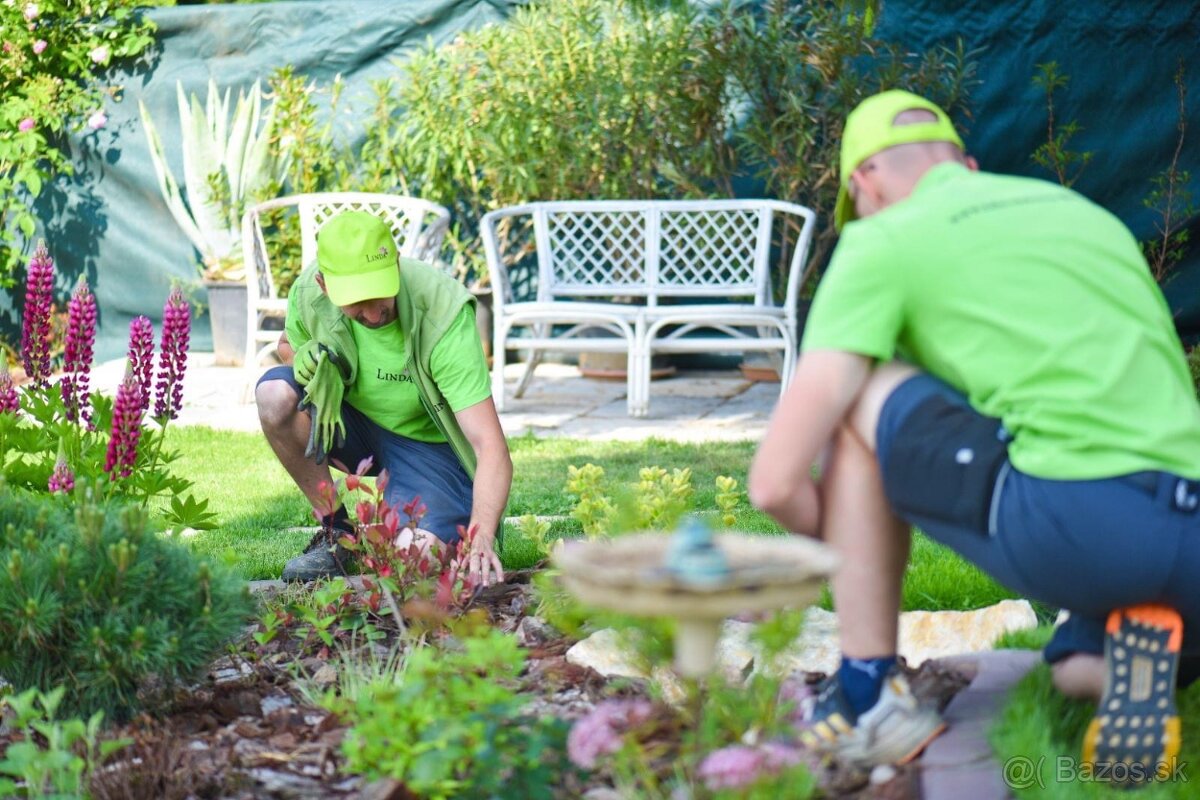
[256,211,512,584]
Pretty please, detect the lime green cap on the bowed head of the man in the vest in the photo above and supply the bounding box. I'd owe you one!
[317,211,400,306]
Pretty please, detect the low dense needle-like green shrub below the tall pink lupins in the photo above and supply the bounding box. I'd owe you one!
[0,482,252,720]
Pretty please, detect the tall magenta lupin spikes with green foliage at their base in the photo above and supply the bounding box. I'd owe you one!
[0,242,214,528]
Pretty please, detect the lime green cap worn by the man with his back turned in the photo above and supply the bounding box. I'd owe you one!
[833,89,962,231]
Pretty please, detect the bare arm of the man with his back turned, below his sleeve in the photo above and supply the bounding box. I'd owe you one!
[748,350,872,535]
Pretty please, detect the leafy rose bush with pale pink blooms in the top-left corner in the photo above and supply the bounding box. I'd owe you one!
[0,0,157,285]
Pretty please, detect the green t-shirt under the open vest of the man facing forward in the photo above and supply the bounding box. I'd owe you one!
[288,305,492,443]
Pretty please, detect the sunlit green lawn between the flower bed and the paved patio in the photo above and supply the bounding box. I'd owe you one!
[168,427,1013,609]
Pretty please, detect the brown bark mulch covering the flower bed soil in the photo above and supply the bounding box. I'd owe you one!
[65,571,968,800]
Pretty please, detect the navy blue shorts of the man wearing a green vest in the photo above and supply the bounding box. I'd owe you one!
[258,366,474,545]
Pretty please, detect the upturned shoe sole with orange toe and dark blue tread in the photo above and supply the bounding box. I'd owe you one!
[1084,604,1183,786]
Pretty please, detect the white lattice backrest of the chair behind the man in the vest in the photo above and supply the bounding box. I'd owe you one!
[241,192,450,307]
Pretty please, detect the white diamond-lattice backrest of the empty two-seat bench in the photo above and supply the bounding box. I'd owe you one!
[485,200,812,306]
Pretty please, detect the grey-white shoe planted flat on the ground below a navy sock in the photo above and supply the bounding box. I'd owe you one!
[800,667,946,766]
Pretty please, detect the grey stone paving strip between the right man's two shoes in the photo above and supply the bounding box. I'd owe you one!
[920,650,1042,800]
